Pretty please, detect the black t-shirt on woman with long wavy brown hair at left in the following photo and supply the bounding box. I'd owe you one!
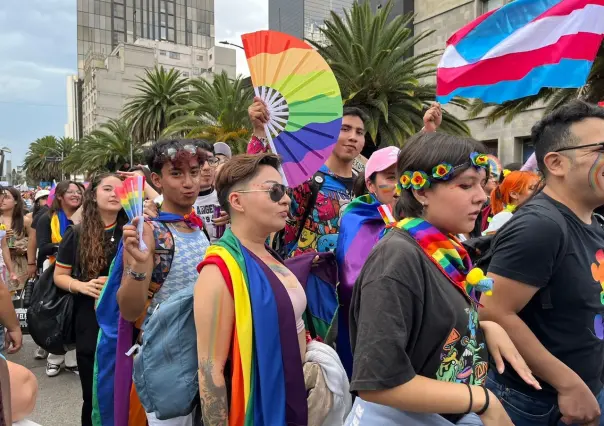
[57,226,122,355]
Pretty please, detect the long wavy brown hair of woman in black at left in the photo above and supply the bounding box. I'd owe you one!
[78,173,128,280]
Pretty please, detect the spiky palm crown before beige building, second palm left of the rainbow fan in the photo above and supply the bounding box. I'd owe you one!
[123,67,189,144]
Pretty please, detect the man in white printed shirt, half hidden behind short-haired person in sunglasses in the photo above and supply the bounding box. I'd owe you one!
[191,139,230,243]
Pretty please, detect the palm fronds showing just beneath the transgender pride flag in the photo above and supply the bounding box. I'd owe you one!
[468,44,604,126]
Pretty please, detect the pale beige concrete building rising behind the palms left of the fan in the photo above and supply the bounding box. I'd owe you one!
[82,39,236,136]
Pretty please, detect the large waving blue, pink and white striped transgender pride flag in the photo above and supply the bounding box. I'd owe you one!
[436,0,604,104]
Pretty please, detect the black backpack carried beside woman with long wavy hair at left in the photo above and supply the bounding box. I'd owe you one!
[26,225,80,355]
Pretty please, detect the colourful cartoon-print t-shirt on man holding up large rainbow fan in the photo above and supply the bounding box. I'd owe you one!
[285,166,353,257]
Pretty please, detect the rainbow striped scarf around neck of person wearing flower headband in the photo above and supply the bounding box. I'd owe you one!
[396,217,473,300]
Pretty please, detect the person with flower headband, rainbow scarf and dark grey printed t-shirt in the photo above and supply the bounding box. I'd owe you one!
[346,133,538,426]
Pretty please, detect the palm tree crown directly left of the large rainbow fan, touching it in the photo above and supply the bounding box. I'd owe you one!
[162,72,254,153]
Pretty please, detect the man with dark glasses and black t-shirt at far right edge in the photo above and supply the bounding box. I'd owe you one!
[480,101,604,426]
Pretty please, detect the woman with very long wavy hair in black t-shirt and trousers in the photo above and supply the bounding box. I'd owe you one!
[54,174,128,426]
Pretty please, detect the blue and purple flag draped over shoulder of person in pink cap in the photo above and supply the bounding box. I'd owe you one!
[336,194,386,377]
